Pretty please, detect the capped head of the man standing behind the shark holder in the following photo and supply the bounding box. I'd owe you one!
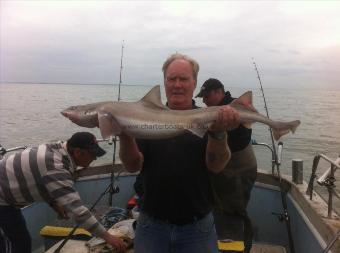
[196,78,225,106]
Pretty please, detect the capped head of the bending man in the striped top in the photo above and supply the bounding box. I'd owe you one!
[67,132,106,167]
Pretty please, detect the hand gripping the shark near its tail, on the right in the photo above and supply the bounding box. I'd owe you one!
[209,105,240,132]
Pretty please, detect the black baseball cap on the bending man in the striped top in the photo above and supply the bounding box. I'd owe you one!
[67,132,106,157]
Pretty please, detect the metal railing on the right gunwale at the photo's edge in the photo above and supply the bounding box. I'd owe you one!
[306,154,340,218]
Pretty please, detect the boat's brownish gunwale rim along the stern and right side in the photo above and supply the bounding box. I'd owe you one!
[24,163,340,252]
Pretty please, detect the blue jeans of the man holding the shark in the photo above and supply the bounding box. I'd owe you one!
[134,213,218,253]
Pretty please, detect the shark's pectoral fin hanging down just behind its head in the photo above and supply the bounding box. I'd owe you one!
[98,112,122,139]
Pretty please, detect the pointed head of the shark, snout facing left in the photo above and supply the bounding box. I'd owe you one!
[61,103,98,128]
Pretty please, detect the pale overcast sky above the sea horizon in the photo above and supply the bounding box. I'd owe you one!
[0,0,340,90]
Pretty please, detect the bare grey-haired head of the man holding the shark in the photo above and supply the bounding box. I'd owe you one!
[162,53,199,110]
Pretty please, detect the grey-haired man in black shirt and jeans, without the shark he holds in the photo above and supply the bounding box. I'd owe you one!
[120,54,239,253]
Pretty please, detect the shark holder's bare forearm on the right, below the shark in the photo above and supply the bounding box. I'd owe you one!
[206,133,231,173]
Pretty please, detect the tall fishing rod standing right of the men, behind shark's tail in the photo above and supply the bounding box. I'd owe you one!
[252,58,295,253]
